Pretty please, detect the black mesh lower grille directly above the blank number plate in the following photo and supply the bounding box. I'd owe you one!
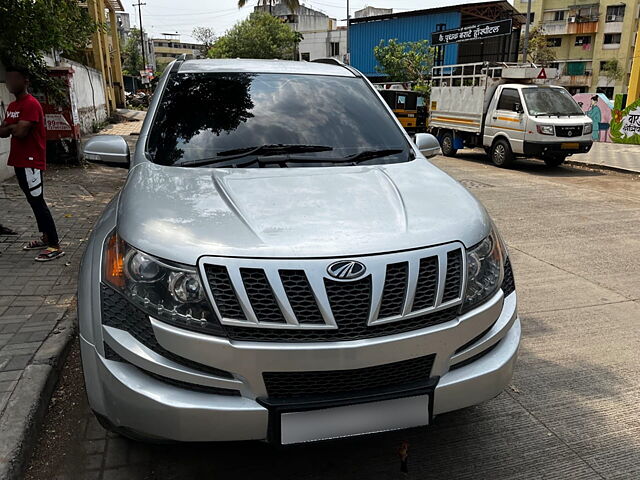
[262,355,435,399]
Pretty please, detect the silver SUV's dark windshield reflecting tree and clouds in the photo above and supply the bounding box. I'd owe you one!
[147,72,413,167]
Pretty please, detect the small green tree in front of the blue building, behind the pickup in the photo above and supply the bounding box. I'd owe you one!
[373,39,434,93]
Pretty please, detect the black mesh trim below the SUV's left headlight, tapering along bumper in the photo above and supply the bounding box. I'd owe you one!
[100,284,233,378]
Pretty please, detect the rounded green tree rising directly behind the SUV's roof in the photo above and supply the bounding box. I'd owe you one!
[207,12,301,60]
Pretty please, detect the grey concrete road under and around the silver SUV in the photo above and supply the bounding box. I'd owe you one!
[27,154,640,480]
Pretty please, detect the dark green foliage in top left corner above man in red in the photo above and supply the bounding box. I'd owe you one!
[0,0,97,89]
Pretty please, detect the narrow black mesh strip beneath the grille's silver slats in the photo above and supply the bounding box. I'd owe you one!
[225,306,460,343]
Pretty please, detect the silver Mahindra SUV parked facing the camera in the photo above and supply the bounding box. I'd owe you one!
[78,60,520,444]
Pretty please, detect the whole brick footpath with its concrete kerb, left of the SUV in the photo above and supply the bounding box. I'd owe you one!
[0,165,126,480]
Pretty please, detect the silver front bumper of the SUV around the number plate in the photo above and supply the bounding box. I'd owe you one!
[80,291,520,441]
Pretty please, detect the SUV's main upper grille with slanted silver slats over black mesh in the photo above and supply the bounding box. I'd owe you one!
[201,244,465,342]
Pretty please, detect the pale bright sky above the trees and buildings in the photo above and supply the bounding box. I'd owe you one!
[121,0,464,41]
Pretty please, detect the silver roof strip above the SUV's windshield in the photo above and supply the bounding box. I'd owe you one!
[178,58,355,77]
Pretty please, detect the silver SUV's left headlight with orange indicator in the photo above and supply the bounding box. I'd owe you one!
[103,233,222,334]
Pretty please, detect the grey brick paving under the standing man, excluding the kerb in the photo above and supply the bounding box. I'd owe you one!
[0,165,126,477]
